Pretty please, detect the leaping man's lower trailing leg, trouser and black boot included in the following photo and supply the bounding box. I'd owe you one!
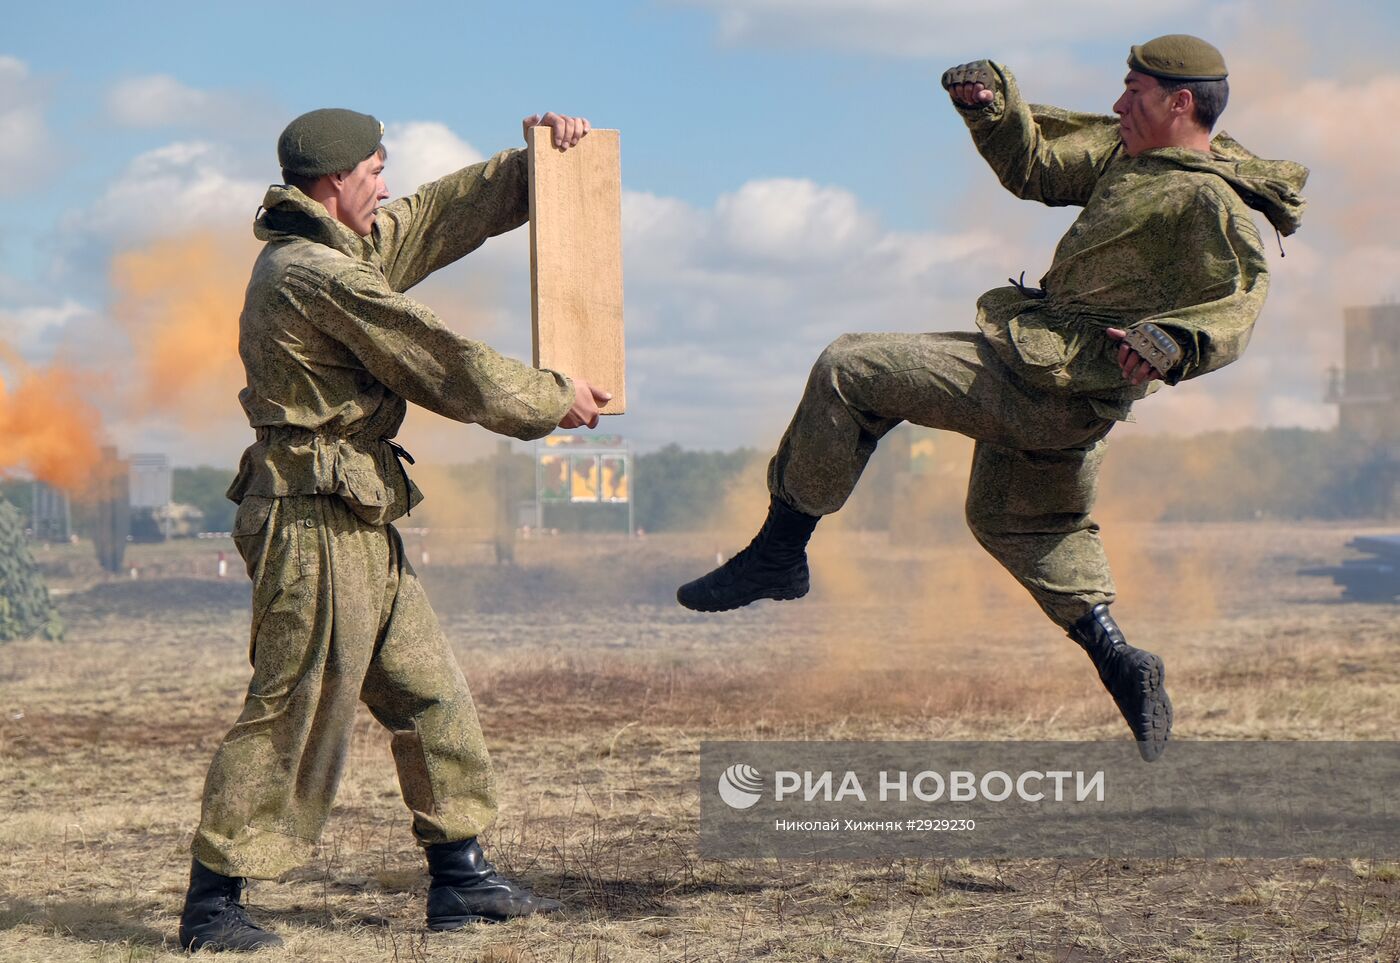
[967,440,1172,761]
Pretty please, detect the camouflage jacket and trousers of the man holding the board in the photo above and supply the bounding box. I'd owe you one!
[193,151,574,879]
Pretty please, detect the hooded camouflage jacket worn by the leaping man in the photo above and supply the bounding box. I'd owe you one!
[959,64,1308,419]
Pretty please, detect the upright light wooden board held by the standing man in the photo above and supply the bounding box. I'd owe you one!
[529,127,627,414]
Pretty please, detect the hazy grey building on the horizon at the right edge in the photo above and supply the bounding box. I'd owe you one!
[1327,304,1400,447]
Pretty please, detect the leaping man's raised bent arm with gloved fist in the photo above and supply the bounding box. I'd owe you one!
[942,60,1119,206]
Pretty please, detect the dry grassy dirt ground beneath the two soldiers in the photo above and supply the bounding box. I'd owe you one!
[0,523,1400,963]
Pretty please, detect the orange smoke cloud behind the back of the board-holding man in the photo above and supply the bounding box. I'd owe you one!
[111,234,256,428]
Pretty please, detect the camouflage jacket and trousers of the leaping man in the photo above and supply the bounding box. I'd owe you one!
[769,64,1308,627]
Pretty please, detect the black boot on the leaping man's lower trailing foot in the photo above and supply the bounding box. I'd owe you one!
[1070,605,1172,763]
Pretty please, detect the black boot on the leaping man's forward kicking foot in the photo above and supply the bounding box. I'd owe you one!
[676,497,820,612]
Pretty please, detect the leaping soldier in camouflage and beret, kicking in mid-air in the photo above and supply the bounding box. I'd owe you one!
[678,35,1308,760]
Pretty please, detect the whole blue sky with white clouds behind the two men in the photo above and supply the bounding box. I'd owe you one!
[0,0,1400,465]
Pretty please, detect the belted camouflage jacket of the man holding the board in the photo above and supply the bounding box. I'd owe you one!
[228,151,574,523]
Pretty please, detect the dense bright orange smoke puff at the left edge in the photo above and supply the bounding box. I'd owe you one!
[0,351,102,490]
